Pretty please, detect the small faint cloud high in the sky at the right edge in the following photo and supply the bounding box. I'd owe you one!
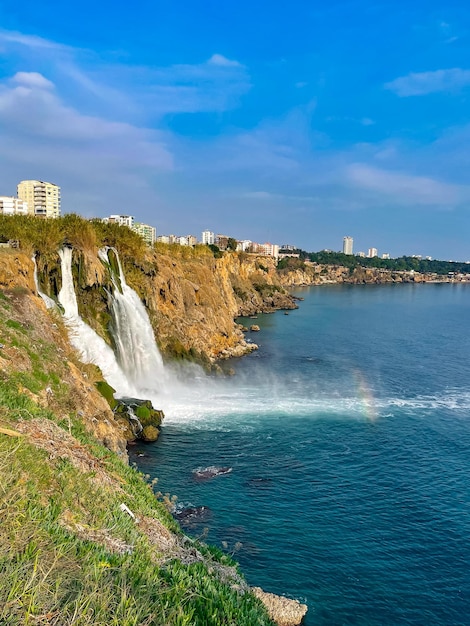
[385,67,470,98]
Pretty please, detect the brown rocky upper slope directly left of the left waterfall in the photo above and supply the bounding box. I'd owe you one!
[0,246,127,457]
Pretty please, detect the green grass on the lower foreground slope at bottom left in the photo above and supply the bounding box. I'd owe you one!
[0,426,271,626]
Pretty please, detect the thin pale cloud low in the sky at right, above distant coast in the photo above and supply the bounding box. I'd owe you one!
[346,163,462,206]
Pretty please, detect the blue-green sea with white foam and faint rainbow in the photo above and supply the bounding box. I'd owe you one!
[131,284,470,626]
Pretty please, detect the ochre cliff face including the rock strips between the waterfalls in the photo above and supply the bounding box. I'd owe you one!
[31,249,296,363]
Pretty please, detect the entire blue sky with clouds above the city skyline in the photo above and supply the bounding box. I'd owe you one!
[0,0,470,260]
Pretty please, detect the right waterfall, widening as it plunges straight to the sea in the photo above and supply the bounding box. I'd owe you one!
[99,248,168,396]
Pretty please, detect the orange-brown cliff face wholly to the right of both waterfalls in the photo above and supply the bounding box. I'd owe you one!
[126,254,295,361]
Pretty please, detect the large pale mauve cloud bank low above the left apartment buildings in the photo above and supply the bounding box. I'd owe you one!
[0,74,173,215]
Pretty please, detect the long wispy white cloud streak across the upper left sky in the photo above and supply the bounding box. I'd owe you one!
[0,30,251,118]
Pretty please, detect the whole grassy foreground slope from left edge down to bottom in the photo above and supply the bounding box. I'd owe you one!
[0,292,272,626]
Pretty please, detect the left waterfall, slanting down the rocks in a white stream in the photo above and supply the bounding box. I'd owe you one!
[58,248,138,396]
